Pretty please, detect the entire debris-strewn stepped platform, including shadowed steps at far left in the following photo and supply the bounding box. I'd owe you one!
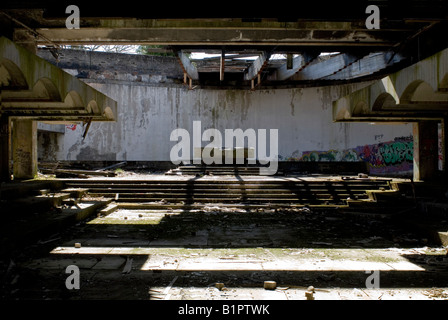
[0,175,428,252]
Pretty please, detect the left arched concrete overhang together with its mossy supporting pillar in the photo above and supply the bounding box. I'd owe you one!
[0,37,117,181]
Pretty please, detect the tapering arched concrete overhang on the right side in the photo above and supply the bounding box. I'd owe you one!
[333,49,448,121]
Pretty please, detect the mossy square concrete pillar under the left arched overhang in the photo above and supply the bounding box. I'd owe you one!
[12,120,37,179]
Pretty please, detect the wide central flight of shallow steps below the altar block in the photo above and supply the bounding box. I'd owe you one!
[65,177,390,206]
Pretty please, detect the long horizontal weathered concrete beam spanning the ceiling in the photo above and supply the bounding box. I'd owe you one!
[14,27,402,47]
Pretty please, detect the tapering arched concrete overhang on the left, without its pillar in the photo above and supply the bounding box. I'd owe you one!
[0,37,117,121]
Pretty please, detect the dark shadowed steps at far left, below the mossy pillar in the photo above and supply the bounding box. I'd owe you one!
[0,180,111,252]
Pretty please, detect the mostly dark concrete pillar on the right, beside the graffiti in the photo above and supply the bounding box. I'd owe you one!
[413,121,439,181]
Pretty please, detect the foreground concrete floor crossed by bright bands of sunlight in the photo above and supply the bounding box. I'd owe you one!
[2,198,448,300]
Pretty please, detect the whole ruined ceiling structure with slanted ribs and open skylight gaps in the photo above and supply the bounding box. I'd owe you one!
[0,0,448,89]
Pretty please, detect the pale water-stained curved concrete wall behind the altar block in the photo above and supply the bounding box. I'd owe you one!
[37,49,412,175]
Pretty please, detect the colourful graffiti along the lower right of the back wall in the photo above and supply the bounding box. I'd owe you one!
[287,136,414,175]
